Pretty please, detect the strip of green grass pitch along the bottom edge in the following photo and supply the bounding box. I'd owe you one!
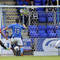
[0,56,60,60]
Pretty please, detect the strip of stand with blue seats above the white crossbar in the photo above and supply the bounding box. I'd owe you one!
[0,0,57,6]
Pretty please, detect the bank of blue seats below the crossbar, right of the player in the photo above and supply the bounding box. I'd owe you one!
[29,8,58,38]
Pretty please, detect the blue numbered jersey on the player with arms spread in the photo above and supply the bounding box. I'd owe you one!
[8,24,25,38]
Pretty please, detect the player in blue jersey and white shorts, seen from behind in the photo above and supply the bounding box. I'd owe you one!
[3,19,27,56]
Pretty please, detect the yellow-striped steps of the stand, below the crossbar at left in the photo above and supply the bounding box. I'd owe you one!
[3,8,19,25]
